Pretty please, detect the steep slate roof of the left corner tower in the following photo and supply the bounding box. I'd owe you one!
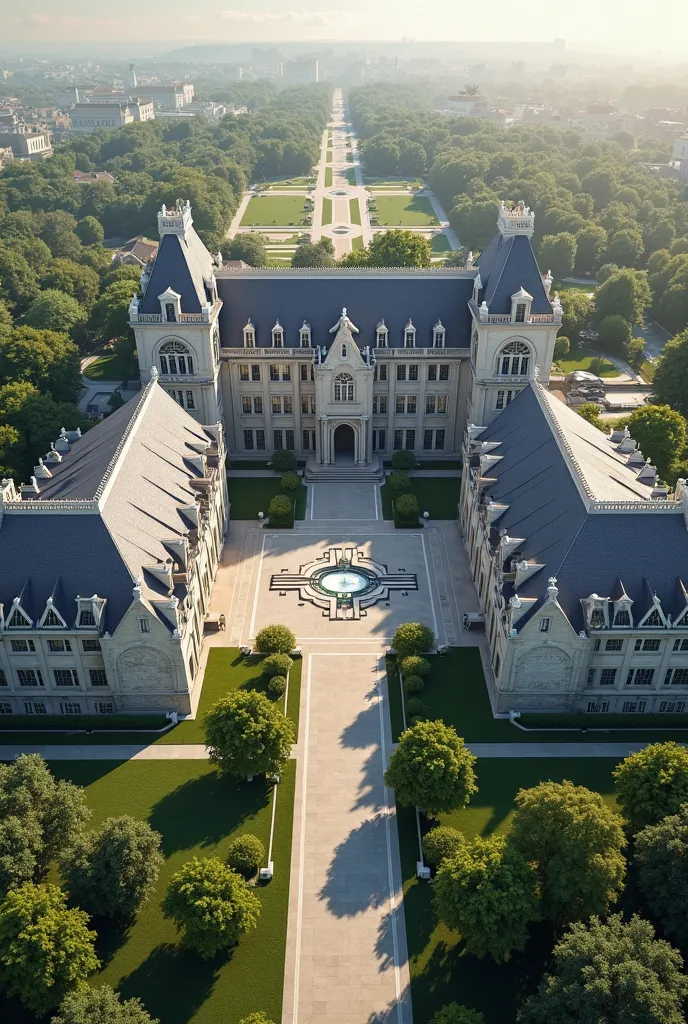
[139,227,213,313]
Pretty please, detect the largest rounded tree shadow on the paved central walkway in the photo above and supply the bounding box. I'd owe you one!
[318,814,389,918]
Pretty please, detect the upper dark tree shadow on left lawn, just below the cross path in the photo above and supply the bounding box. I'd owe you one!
[148,771,272,857]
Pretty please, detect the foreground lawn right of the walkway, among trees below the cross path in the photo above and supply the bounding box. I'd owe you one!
[397,758,616,1024]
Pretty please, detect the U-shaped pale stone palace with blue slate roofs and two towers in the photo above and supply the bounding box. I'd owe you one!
[0,203,688,715]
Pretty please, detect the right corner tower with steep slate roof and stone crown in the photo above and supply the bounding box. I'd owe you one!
[468,203,561,426]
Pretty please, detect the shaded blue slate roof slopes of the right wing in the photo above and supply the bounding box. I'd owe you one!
[479,387,688,631]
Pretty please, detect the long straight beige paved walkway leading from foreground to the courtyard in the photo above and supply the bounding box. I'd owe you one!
[283,651,412,1024]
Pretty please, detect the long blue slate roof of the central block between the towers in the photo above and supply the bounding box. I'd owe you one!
[216,269,475,348]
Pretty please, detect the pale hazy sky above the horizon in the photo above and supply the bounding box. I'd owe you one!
[0,0,688,50]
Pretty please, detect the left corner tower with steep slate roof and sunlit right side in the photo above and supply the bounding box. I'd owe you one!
[129,200,223,423]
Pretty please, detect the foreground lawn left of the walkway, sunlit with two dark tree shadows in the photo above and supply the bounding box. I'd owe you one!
[0,761,296,1024]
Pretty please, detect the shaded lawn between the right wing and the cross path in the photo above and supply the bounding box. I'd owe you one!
[388,647,686,743]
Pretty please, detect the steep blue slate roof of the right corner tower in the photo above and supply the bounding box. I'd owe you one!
[477,231,552,314]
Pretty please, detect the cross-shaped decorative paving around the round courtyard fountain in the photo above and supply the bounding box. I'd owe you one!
[270,547,418,620]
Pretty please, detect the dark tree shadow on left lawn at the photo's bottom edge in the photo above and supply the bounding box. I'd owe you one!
[118,942,227,1024]
